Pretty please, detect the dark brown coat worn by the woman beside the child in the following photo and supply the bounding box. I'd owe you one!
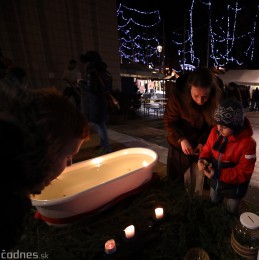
[164,76,219,150]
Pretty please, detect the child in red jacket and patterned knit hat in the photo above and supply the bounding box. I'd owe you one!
[198,99,256,215]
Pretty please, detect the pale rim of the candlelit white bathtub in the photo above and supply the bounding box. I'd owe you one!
[30,147,159,207]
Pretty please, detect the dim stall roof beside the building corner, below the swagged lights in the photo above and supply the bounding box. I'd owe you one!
[121,63,164,80]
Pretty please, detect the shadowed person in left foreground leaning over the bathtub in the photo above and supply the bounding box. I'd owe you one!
[0,82,88,252]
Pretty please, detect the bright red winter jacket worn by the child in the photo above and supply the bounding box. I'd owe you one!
[199,118,256,185]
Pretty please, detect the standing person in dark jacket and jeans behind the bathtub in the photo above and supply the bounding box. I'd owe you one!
[80,51,112,154]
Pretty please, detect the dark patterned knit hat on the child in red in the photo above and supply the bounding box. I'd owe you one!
[214,98,245,133]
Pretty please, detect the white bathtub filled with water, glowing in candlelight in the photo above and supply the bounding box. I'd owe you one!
[31,148,158,224]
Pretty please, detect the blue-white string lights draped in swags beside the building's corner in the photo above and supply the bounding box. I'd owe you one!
[117,4,161,67]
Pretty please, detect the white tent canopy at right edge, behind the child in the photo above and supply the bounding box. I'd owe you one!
[218,70,259,86]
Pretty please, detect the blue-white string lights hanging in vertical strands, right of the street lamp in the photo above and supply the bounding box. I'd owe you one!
[172,0,259,69]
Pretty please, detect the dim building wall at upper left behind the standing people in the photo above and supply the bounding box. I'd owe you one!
[0,0,121,89]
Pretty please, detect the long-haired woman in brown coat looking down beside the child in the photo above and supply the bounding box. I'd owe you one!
[164,68,222,191]
